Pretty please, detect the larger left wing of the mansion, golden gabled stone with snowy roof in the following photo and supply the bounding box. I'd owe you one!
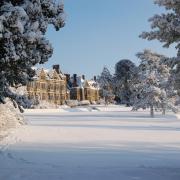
[27,66,69,105]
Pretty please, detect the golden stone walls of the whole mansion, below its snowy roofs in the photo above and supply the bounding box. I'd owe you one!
[27,69,100,105]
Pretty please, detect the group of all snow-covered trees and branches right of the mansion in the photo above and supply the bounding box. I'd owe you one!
[98,0,180,117]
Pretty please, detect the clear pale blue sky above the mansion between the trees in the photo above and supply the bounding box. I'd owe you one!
[45,0,175,78]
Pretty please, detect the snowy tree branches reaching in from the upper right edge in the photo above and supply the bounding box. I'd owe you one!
[140,0,180,90]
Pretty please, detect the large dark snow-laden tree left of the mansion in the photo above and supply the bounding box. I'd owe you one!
[0,0,64,111]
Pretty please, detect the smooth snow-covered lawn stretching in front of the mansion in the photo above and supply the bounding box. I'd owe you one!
[0,106,180,180]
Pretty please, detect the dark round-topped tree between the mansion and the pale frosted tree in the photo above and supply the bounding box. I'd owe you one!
[114,59,137,106]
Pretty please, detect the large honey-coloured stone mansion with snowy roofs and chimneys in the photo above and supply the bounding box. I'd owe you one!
[27,65,100,105]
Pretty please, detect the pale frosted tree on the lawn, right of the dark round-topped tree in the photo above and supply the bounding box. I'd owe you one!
[133,50,175,117]
